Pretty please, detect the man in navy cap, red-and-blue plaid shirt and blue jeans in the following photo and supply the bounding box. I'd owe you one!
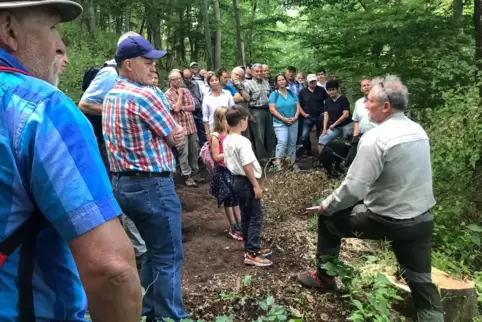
[102,36,188,322]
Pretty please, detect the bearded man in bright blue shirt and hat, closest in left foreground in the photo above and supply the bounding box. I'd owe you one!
[0,0,141,322]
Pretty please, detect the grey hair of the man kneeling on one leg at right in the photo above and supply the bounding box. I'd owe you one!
[372,75,408,111]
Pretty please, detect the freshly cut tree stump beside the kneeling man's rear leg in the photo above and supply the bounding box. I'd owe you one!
[387,267,478,322]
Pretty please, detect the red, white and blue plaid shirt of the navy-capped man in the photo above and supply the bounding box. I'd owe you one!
[102,76,176,172]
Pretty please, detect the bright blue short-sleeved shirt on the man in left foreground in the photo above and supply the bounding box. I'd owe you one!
[0,49,121,322]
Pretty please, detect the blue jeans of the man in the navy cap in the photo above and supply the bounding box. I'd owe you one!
[112,175,188,321]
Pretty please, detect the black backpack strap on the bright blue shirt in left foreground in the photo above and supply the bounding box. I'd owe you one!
[0,207,47,322]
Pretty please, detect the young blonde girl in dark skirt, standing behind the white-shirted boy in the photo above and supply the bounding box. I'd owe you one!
[210,106,243,241]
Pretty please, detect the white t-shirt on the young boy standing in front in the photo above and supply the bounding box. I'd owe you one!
[223,134,262,179]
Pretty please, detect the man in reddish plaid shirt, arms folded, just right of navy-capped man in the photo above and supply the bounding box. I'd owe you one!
[165,71,204,187]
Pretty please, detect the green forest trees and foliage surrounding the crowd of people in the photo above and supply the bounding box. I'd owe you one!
[60,0,482,321]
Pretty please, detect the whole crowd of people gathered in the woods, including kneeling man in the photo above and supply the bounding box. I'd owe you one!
[0,0,444,322]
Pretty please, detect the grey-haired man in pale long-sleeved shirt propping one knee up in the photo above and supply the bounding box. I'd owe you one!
[298,75,444,321]
